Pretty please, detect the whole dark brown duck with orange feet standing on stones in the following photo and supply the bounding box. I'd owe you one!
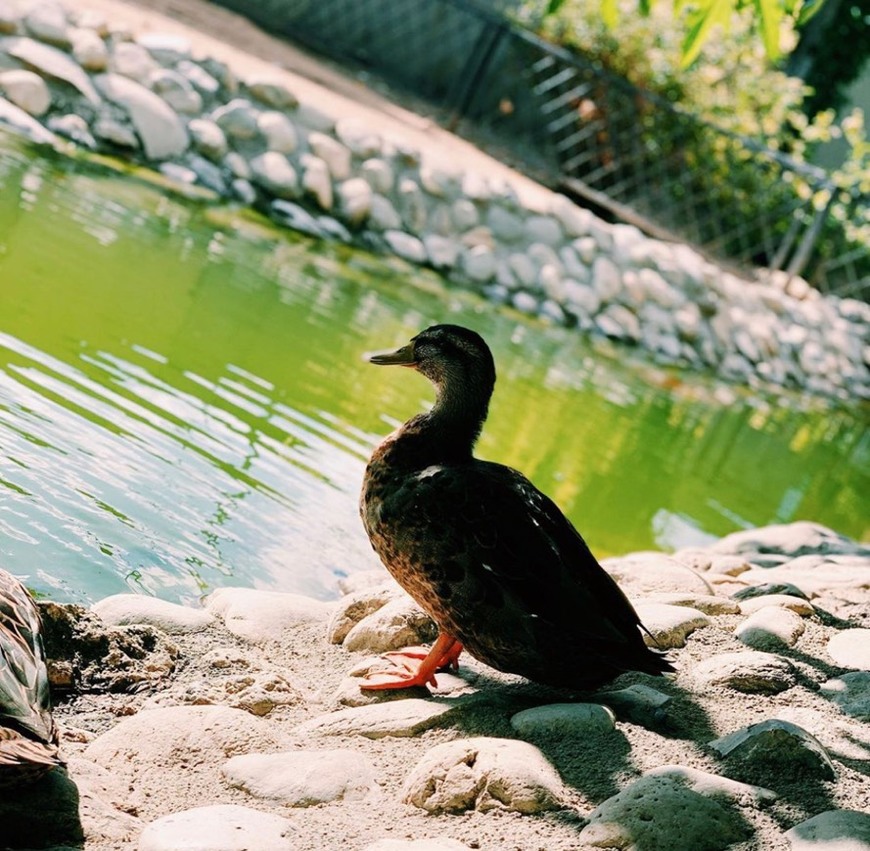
[360,325,673,689]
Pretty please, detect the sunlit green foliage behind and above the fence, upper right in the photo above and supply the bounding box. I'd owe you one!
[520,0,870,288]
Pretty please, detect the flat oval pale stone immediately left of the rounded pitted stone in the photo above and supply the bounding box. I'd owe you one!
[221,750,378,807]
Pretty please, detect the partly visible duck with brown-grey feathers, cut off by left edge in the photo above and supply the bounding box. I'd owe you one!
[0,570,62,788]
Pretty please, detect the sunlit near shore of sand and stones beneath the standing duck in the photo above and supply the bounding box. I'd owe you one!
[0,522,870,851]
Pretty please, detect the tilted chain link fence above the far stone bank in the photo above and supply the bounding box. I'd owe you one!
[211,0,870,300]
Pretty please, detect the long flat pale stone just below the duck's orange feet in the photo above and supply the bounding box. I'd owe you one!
[293,698,453,739]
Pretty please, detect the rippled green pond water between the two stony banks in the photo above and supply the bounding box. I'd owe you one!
[0,133,870,601]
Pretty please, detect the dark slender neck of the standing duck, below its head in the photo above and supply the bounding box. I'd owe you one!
[385,372,492,469]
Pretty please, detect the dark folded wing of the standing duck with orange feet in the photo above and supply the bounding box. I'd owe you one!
[398,461,669,673]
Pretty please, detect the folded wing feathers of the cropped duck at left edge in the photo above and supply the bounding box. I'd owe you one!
[0,570,57,743]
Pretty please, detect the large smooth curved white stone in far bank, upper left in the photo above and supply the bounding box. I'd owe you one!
[94,74,188,160]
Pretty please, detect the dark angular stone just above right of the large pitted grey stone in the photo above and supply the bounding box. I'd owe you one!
[710,718,837,785]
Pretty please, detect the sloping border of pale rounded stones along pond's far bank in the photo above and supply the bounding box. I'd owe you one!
[0,2,870,400]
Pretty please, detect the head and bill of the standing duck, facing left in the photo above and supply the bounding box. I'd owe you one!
[368,325,495,401]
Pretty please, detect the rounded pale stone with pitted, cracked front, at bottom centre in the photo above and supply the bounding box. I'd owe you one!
[405,737,565,814]
